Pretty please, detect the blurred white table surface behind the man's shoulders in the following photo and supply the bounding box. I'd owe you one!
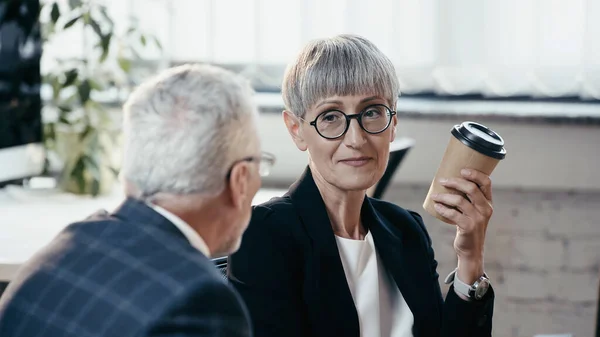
[0,185,285,282]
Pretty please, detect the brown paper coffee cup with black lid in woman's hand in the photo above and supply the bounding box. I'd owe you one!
[423,122,506,222]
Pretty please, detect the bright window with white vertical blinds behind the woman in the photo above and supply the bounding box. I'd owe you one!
[45,0,600,100]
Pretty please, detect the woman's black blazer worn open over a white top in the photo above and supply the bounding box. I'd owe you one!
[228,169,494,337]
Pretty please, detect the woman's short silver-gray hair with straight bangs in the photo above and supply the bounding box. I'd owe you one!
[281,35,400,117]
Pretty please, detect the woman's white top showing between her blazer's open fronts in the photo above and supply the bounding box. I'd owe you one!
[335,232,414,337]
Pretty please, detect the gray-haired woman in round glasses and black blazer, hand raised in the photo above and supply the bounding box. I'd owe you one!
[229,35,494,337]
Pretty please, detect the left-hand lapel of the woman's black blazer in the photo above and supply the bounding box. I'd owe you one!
[288,168,360,337]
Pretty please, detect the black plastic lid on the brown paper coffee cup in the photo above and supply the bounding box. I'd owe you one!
[451,122,506,159]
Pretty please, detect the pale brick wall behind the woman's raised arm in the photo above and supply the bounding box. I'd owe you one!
[385,184,600,337]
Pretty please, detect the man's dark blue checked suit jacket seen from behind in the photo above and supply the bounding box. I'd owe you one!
[0,199,251,337]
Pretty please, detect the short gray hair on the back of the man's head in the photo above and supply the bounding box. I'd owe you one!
[121,65,258,197]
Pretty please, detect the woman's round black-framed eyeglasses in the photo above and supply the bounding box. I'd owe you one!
[300,104,396,139]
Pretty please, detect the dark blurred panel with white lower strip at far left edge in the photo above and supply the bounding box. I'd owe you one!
[0,0,43,182]
